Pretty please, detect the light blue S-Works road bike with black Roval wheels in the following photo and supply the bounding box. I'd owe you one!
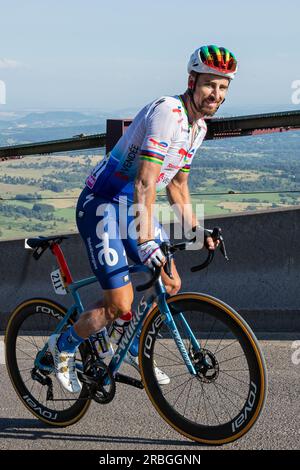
[5,229,267,445]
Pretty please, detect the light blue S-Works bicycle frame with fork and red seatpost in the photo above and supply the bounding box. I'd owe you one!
[35,246,200,376]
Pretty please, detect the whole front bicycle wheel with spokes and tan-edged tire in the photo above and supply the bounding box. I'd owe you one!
[139,293,267,445]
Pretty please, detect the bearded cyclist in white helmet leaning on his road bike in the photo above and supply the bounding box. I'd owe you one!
[49,45,237,393]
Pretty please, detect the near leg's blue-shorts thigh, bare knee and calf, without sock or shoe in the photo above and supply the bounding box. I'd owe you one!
[75,185,133,338]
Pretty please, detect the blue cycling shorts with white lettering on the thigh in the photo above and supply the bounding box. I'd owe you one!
[76,187,168,290]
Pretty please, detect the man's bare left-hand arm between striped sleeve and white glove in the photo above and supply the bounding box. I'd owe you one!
[134,160,161,243]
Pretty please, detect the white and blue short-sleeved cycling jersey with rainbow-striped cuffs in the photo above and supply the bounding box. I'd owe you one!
[86,96,207,203]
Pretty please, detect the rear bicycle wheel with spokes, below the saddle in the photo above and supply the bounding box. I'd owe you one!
[5,299,90,426]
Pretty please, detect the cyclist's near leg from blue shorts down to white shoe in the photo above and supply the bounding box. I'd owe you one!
[48,189,133,393]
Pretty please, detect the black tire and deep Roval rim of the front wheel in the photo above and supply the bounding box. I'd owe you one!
[139,293,267,445]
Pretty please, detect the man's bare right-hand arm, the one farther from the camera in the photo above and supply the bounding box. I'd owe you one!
[167,171,199,230]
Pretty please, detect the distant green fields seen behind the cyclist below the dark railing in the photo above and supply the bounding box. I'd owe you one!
[0,152,300,239]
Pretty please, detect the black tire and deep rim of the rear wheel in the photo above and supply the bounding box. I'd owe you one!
[5,298,90,427]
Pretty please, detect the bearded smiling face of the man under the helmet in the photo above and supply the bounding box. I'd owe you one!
[194,73,230,116]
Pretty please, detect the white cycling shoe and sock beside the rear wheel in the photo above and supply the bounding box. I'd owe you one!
[48,335,82,393]
